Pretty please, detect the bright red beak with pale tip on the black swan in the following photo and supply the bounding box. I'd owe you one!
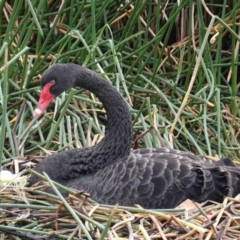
[33,83,54,118]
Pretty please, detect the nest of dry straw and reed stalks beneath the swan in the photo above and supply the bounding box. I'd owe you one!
[0,175,240,240]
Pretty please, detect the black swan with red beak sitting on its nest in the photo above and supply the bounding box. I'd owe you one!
[30,64,240,208]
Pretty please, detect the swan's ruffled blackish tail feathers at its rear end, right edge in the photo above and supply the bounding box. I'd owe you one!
[185,158,240,202]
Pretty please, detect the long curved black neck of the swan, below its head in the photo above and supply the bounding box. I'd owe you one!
[71,64,132,172]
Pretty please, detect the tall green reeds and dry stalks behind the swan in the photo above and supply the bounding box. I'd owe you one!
[0,0,240,238]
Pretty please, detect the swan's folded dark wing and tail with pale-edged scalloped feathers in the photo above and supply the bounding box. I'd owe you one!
[71,148,240,208]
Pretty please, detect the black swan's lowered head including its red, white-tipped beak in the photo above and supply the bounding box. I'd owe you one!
[33,64,74,117]
